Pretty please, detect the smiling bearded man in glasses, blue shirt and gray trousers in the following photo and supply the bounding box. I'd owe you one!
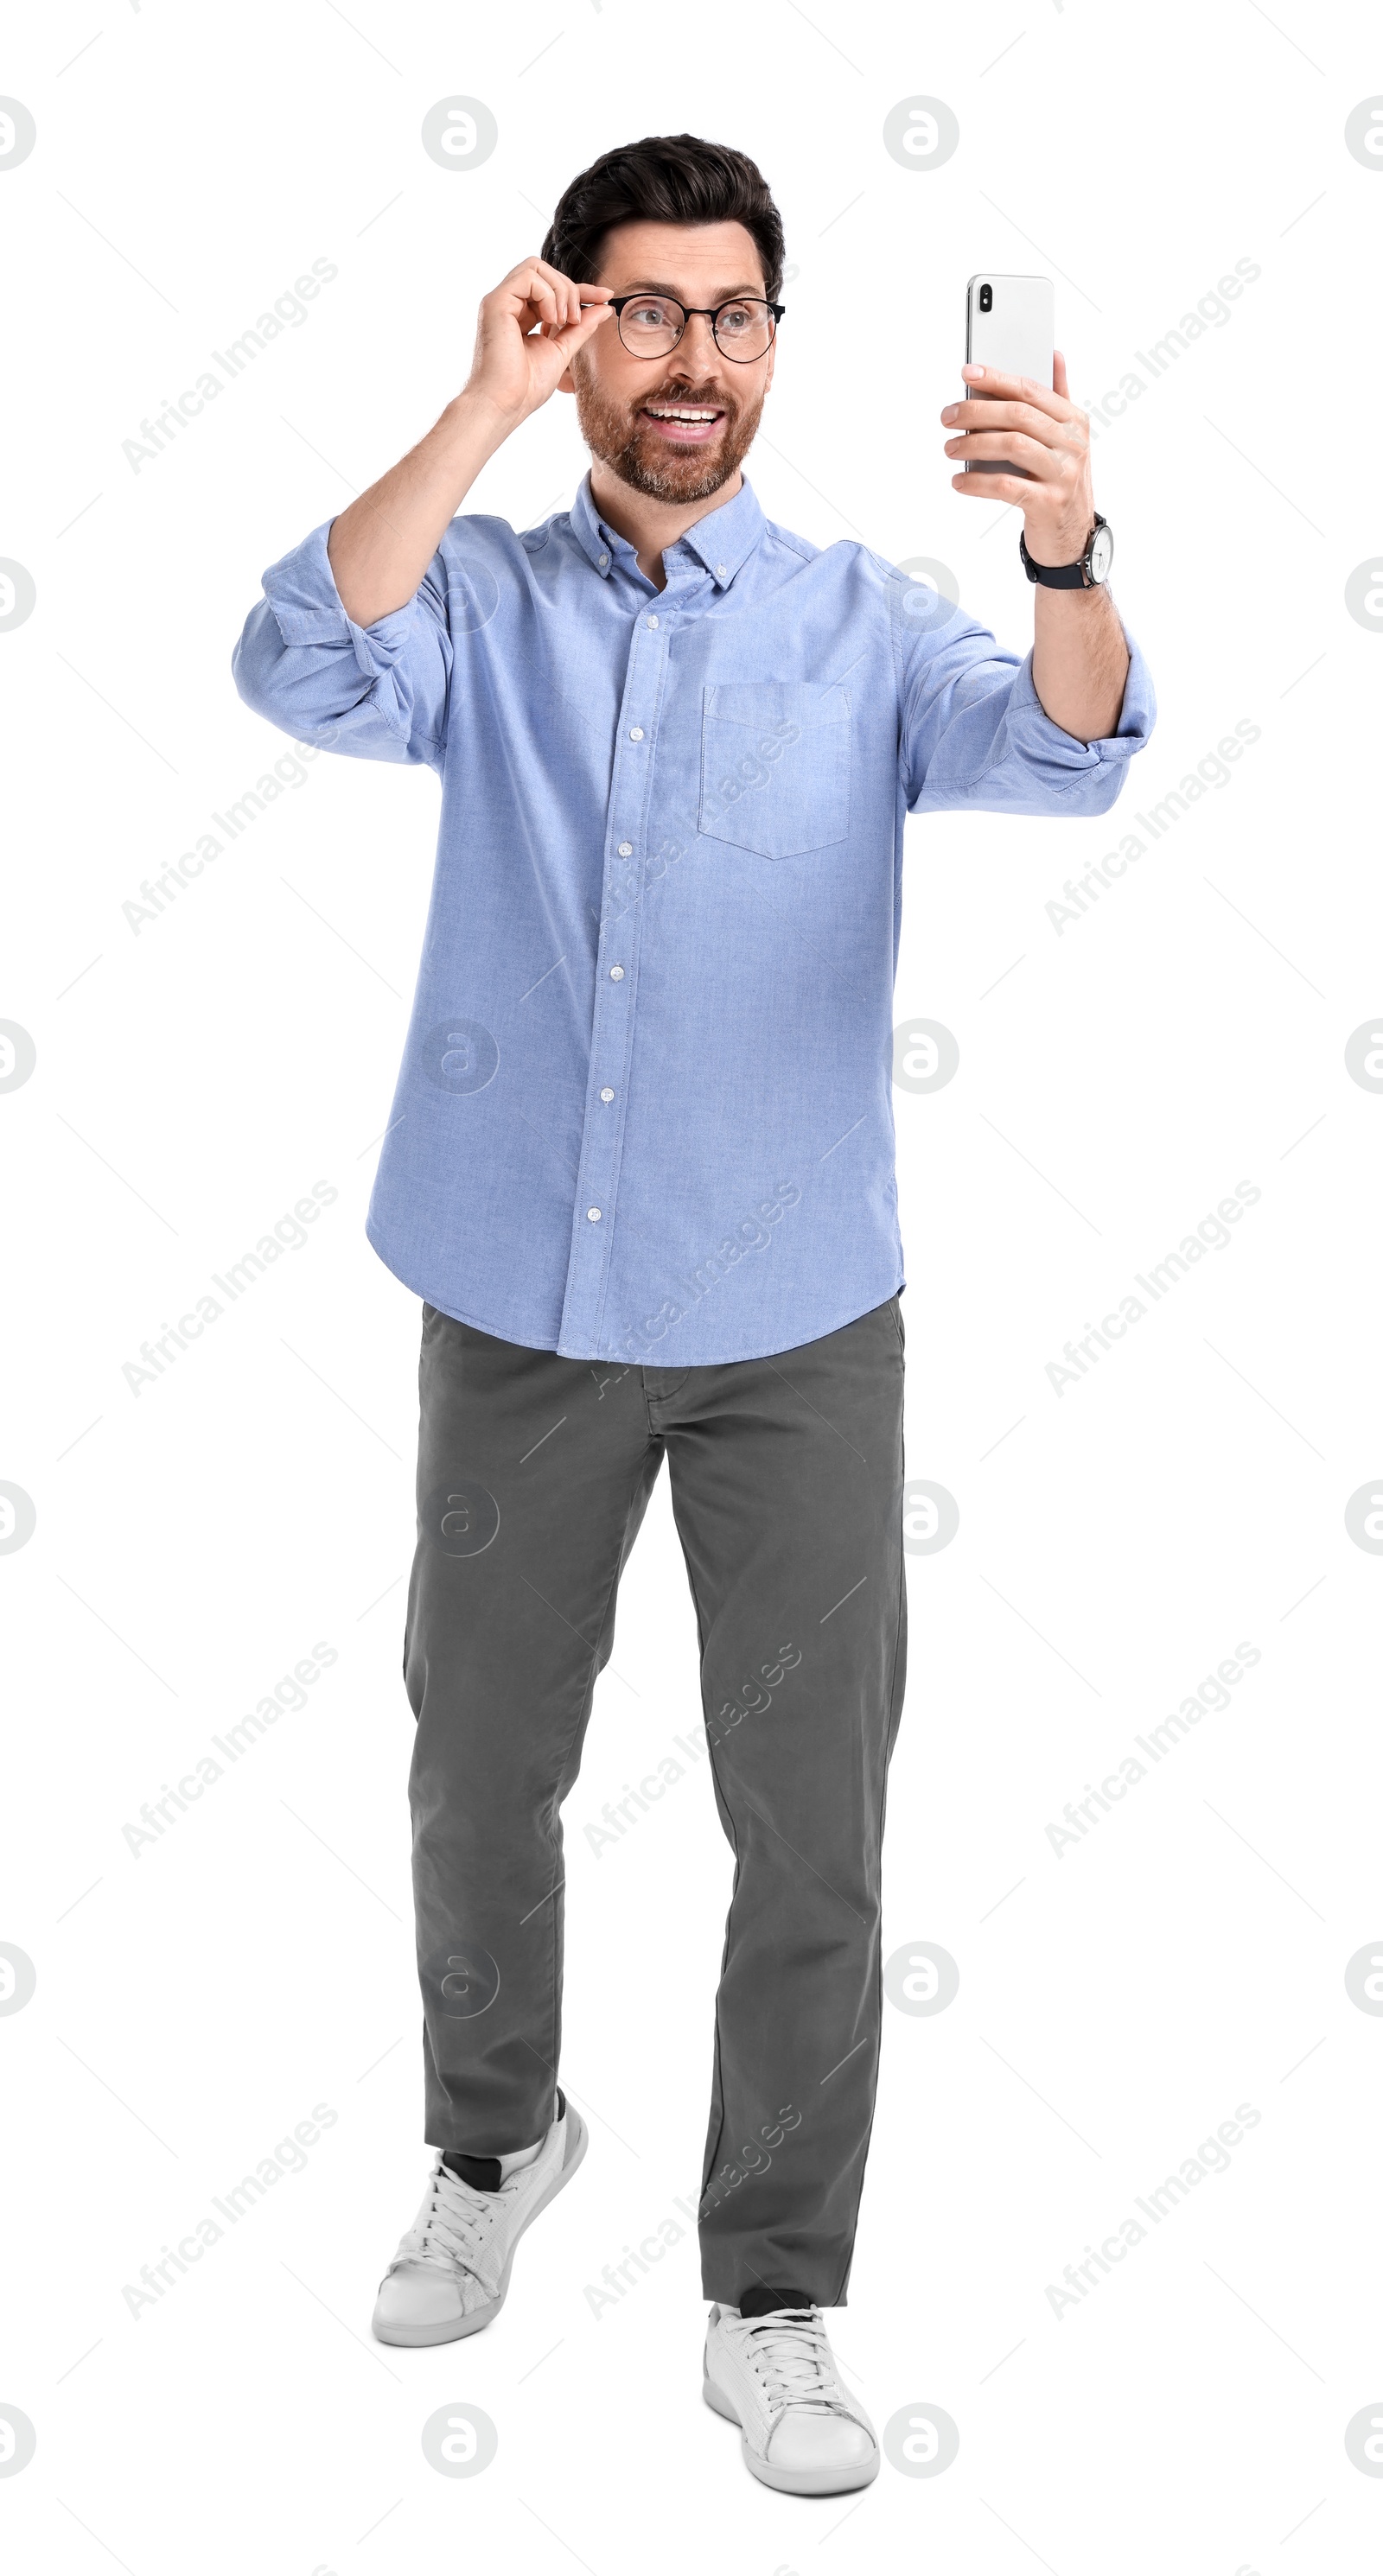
[234,134,1154,2494]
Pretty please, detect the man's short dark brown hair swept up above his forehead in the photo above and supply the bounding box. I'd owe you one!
[541,134,783,304]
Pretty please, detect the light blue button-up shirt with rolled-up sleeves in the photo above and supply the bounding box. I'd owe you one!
[234,479,1154,1368]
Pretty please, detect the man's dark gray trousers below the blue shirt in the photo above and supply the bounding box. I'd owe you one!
[405,1295,907,2306]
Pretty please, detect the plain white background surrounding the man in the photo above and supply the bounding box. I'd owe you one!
[0,0,1383,2576]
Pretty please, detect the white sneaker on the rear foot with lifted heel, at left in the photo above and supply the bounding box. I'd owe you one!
[371,2102,587,2344]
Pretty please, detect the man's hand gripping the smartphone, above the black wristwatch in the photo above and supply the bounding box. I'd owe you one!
[940,350,1094,564]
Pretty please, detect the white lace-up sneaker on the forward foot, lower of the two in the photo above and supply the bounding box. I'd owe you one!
[700,2308,878,2496]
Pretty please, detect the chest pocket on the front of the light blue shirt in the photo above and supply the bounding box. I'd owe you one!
[698,680,850,858]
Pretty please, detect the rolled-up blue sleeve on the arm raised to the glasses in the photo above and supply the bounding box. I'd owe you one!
[232,520,450,767]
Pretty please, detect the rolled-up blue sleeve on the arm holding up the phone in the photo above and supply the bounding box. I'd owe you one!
[902,600,1157,814]
